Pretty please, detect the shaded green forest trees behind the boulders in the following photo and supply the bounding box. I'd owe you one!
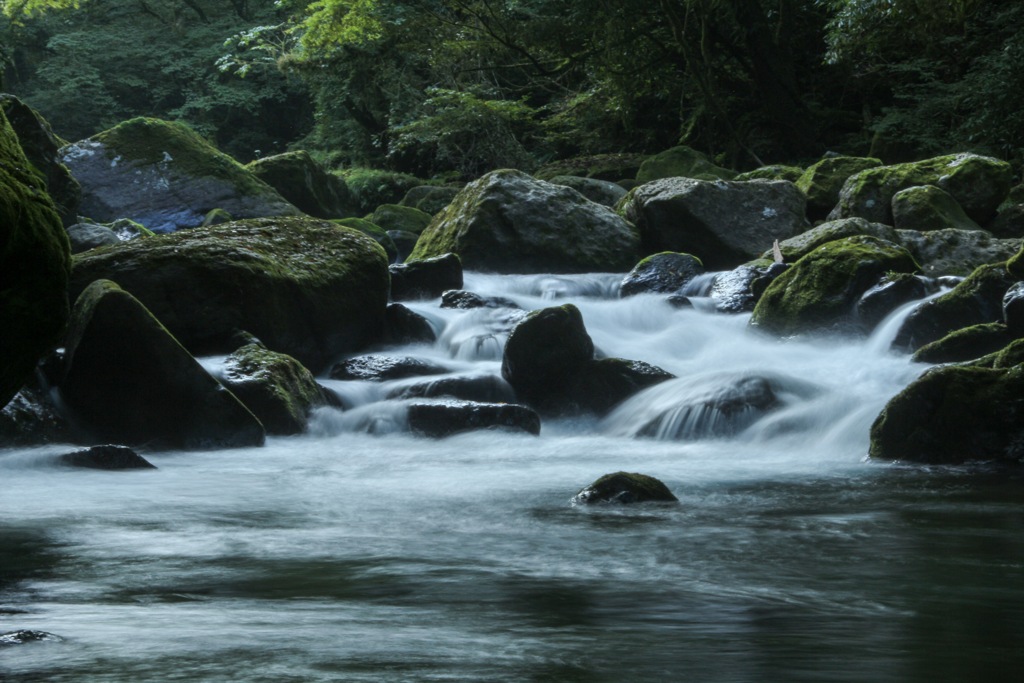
[0,0,1024,179]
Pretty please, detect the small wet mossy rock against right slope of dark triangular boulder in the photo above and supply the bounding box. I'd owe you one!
[220,344,328,434]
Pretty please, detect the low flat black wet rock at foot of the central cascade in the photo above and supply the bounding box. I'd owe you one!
[409,400,541,438]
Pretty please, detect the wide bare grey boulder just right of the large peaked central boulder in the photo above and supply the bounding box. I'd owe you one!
[620,178,807,270]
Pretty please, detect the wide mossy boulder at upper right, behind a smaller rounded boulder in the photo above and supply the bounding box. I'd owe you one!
[828,154,1013,225]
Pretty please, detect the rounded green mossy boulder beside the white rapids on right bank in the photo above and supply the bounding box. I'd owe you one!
[751,236,918,337]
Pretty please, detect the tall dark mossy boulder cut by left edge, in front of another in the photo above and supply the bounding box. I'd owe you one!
[0,105,71,408]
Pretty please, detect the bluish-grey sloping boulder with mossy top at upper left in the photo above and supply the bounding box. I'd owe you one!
[60,118,299,232]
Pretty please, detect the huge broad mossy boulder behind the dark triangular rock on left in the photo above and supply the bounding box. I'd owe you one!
[72,218,388,373]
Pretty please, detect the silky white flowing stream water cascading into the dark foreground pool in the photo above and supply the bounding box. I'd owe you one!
[0,273,1024,683]
